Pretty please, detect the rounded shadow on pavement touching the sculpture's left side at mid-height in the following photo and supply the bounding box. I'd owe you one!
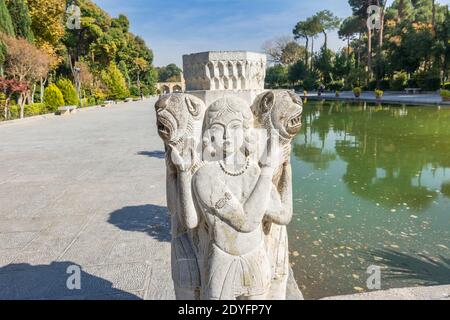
[108,204,171,242]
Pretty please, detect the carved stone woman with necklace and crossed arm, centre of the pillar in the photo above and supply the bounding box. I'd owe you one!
[192,98,281,300]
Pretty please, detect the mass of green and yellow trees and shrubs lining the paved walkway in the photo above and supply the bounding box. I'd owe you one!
[0,0,156,120]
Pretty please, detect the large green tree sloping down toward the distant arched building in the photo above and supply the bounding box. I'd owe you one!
[63,0,156,95]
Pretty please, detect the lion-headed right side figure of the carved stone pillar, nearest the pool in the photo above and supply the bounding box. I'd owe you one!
[252,90,303,299]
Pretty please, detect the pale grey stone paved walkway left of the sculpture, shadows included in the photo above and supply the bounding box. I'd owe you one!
[0,99,174,299]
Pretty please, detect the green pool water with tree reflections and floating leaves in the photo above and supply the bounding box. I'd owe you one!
[289,102,450,299]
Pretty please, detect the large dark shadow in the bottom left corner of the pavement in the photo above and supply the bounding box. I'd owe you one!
[0,262,140,300]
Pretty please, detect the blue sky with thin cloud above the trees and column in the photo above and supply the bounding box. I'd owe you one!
[94,0,449,66]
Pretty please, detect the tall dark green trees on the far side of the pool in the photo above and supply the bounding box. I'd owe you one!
[290,0,450,91]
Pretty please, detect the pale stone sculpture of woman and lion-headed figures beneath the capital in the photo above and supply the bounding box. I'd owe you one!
[156,53,302,300]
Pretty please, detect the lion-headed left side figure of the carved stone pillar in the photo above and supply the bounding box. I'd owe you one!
[155,93,206,300]
